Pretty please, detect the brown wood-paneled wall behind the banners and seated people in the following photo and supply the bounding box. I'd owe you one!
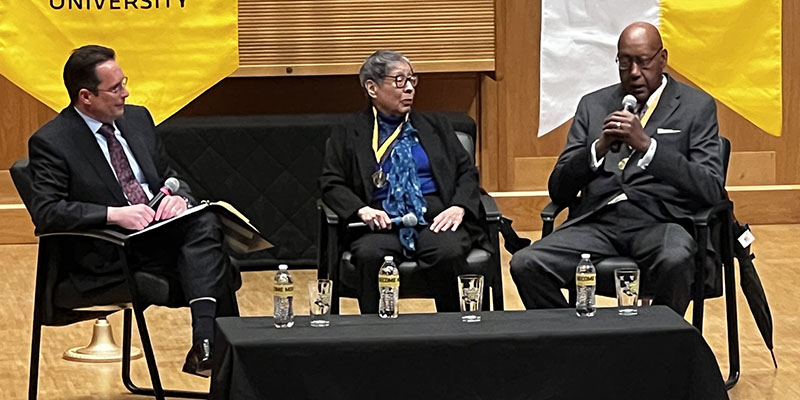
[0,0,800,222]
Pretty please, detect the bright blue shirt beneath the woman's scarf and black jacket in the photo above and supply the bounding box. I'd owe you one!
[372,113,439,202]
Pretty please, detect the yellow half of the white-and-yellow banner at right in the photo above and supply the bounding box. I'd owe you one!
[661,0,783,136]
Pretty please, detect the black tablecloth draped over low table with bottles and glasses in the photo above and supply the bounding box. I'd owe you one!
[211,306,728,400]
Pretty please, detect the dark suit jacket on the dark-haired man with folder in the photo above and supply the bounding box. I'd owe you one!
[28,105,194,291]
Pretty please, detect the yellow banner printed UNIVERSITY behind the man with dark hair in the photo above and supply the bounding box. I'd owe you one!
[0,0,239,123]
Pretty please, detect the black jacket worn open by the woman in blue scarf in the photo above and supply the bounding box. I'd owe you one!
[320,108,484,248]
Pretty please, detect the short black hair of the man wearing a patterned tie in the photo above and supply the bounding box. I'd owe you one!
[64,44,116,105]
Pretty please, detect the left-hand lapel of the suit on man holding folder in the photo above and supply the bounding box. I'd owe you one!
[64,106,128,204]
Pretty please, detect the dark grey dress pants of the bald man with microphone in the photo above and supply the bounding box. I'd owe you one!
[511,200,697,315]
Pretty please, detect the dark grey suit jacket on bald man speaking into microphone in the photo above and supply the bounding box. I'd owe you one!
[548,76,724,223]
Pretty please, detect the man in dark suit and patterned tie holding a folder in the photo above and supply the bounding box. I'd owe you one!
[28,46,238,376]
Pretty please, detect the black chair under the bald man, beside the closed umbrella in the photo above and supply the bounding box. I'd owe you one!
[541,137,740,389]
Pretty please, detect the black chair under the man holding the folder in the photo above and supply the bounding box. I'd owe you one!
[10,159,208,399]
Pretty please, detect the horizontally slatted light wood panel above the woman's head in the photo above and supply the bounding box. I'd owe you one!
[236,0,495,76]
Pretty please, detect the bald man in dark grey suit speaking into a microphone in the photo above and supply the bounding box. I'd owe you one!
[511,22,723,315]
